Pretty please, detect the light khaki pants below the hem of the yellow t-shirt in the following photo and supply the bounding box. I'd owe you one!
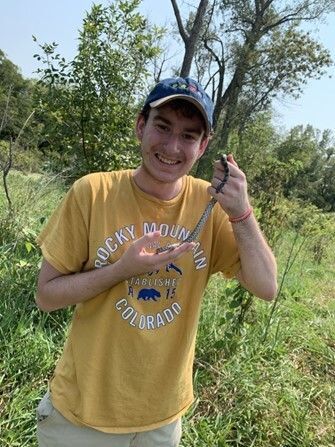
[37,392,181,447]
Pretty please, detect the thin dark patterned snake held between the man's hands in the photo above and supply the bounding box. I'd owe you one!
[156,154,229,254]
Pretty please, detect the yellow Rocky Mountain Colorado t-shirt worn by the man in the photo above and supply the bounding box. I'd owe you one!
[38,170,240,433]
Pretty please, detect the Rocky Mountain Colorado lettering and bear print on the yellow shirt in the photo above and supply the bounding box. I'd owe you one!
[95,222,207,330]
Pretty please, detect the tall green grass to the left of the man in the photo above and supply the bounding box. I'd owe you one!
[0,172,66,447]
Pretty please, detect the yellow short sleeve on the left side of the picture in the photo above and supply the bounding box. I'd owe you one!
[37,180,89,274]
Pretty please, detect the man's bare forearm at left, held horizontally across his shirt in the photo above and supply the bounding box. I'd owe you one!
[36,262,127,312]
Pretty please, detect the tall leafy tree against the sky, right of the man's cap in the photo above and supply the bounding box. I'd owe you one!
[172,0,334,177]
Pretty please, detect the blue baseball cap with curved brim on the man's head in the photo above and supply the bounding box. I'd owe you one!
[144,77,214,135]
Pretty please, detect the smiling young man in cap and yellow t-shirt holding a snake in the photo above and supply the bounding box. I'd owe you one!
[37,78,276,447]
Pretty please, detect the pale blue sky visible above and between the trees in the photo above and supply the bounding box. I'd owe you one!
[0,0,335,131]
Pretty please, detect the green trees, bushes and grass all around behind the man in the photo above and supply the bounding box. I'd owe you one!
[0,0,335,447]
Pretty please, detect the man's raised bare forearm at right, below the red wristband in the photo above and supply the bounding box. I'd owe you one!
[232,214,277,300]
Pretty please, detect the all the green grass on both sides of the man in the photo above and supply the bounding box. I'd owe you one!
[0,173,335,447]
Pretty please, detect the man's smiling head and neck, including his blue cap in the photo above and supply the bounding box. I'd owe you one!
[134,78,213,200]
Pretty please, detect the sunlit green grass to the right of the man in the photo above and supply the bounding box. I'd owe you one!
[182,234,335,447]
